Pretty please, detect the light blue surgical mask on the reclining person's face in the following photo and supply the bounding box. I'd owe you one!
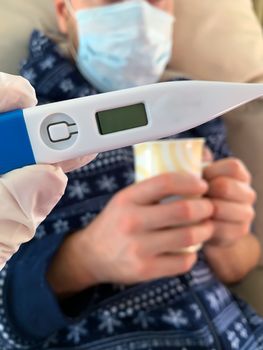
[71,0,174,92]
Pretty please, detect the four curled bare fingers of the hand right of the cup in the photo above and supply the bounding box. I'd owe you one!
[204,158,256,245]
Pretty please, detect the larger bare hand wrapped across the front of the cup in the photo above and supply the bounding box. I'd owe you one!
[48,173,213,293]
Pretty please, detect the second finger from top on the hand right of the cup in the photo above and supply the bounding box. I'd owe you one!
[207,176,256,204]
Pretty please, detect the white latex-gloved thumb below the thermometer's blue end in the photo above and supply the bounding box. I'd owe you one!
[0,165,67,268]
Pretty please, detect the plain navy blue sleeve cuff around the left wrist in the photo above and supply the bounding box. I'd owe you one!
[3,235,75,342]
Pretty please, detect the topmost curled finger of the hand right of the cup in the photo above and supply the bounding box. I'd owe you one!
[203,158,251,183]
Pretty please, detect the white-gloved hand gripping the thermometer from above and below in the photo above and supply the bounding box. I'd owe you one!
[0,73,94,268]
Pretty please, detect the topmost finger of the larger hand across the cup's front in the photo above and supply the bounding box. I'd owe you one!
[125,173,207,205]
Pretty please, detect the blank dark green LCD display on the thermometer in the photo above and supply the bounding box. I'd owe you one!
[96,103,148,135]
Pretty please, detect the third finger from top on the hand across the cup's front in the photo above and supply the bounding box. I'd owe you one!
[140,221,214,256]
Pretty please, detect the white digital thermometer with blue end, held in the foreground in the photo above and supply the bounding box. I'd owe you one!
[0,81,263,174]
